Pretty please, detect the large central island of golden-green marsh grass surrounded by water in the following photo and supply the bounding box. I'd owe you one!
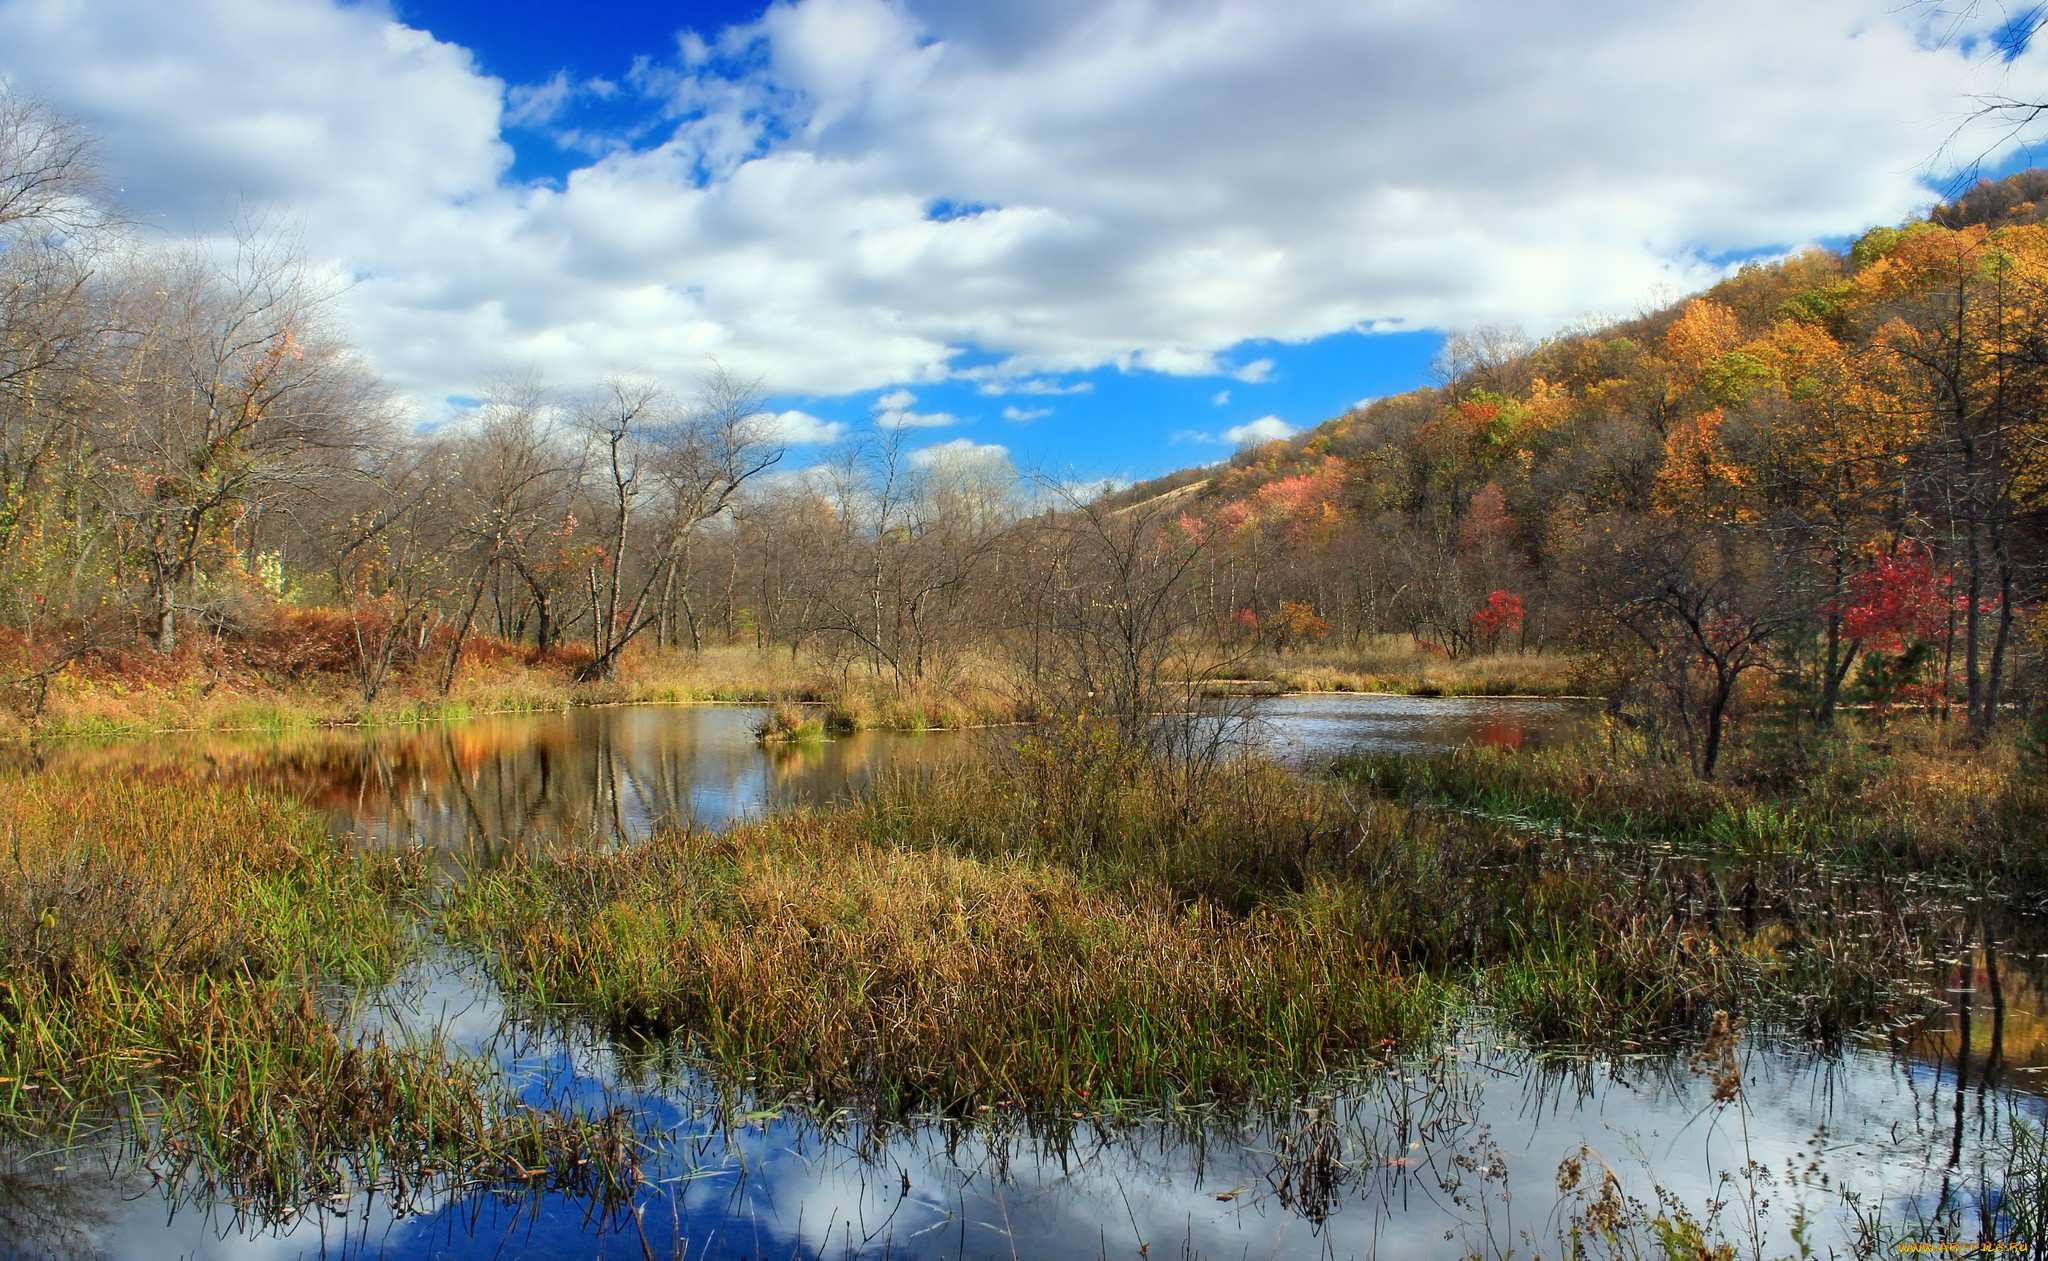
[444,735,1921,1110]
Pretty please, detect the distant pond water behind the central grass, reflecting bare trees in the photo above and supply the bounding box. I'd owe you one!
[16,696,1585,847]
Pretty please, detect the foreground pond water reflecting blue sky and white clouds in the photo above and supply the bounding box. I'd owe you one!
[19,958,2042,1261]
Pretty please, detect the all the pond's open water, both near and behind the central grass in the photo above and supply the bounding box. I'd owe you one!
[0,696,2048,1259]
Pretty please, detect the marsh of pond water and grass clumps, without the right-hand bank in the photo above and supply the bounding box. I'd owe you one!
[0,696,2048,1257]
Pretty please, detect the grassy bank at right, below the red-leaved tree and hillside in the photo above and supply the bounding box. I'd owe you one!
[1337,719,2048,907]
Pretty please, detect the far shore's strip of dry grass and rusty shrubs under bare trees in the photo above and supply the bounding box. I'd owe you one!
[0,610,1583,739]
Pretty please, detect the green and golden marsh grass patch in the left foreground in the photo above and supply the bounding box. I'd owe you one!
[0,772,631,1216]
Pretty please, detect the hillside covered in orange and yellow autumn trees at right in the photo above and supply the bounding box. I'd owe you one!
[1116,170,2048,769]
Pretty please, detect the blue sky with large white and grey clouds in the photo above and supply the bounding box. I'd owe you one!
[0,0,2048,479]
